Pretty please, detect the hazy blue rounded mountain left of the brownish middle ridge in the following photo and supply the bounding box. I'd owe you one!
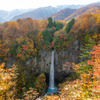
[12,6,58,21]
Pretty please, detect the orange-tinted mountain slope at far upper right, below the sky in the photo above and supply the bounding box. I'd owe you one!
[65,3,100,21]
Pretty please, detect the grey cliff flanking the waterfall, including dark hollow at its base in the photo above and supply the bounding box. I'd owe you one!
[8,40,81,84]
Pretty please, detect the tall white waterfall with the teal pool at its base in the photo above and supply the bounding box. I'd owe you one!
[47,50,57,94]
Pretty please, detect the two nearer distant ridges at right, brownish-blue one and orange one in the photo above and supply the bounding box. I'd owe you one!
[44,2,100,21]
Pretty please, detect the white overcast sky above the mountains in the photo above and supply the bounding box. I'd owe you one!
[0,0,100,11]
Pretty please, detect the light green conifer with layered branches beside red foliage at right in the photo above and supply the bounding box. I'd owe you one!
[79,35,96,73]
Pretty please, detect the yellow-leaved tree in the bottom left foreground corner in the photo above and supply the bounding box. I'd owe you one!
[0,63,16,100]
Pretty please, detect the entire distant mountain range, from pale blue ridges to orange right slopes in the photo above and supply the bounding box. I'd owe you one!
[0,2,100,23]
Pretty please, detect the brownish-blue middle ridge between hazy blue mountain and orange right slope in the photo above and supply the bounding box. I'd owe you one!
[50,8,76,20]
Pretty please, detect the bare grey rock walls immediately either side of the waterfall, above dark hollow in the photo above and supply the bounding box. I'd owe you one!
[38,41,81,72]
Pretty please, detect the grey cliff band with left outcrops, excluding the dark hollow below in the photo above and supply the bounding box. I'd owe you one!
[8,40,81,73]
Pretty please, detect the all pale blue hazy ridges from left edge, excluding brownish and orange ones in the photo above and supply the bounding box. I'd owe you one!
[0,5,83,23]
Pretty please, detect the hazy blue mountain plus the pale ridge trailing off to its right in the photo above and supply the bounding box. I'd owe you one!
[12,5,83,21]
